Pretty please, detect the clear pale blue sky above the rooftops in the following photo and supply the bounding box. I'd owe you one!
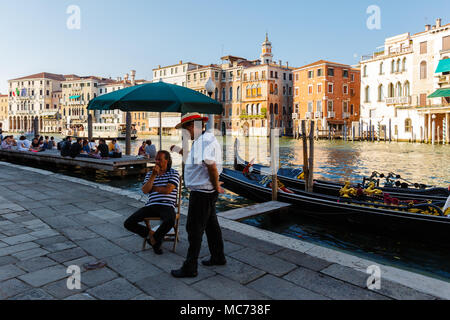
[0,0,450,94]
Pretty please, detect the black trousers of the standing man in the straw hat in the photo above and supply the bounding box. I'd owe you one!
[183,191,225,272]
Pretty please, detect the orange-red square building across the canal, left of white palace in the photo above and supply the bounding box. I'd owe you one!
[293,60,360,136]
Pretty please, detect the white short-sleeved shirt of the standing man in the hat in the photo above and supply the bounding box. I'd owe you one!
[184,131,223,192]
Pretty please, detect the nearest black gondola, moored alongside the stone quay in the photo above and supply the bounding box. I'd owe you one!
[220,169,450,243]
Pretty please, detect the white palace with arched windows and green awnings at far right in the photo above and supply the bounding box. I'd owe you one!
[361,19,450,142]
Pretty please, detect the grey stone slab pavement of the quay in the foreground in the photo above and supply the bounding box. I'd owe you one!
[0,162,442,300]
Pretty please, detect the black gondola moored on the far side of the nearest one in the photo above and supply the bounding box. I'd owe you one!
[234,139,450,201]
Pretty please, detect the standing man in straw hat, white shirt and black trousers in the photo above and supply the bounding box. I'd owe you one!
[171,113,226,278]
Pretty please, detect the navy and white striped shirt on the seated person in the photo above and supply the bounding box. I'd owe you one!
[144,168,180,208]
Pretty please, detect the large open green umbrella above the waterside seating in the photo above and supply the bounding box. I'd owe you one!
[88,82,223,114]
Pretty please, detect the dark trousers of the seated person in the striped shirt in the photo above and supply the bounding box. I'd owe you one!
[123,205,175,247]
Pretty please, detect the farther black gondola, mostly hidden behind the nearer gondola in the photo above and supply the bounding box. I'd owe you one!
[234,139,450,201]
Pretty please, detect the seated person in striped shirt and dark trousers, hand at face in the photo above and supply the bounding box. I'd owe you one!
[124,151,180,254]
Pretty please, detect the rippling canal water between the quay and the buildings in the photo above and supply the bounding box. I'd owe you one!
[4,136,450,282]
